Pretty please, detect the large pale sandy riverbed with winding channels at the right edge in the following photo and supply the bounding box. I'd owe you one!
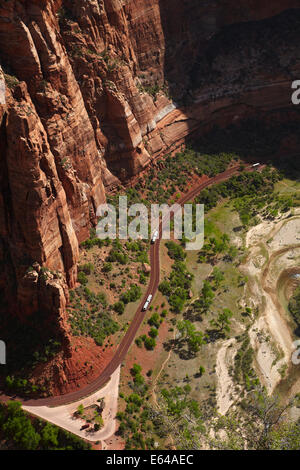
[243,217,300,393]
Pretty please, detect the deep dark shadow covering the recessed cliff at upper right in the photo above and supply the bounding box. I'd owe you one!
[160,5,300,179]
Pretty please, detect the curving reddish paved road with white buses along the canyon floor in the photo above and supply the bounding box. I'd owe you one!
[0,165,253,406]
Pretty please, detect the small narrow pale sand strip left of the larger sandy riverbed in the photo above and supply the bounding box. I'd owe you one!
[216,338,237,415]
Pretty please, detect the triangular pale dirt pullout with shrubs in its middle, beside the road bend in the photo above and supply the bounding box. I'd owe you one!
[23,367,120,444]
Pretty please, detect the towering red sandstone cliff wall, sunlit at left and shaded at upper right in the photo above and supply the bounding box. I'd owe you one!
[0,0,300,392]
